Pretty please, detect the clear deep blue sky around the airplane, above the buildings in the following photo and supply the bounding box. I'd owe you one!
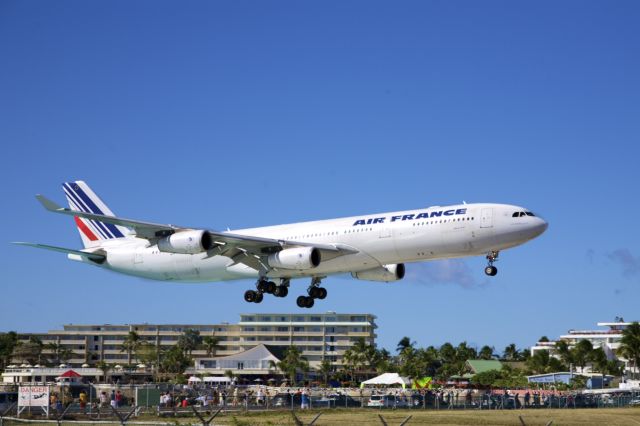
[0,0,640,351]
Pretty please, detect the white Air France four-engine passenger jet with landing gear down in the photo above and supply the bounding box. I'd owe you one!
[15,181,548,308]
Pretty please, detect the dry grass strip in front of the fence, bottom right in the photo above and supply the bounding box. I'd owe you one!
[158,407,640,426]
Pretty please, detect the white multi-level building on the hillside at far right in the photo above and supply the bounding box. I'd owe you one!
[531,321,633,371]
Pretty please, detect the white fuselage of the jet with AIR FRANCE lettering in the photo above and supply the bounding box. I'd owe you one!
[75,204,547,282]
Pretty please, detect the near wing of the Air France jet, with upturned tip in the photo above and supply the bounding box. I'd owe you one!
[36,194,357,270]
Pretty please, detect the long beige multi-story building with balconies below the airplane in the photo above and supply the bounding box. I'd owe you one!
[6,312,377,367]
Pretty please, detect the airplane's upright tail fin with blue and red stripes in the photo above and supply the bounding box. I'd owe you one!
[62,180,129,248]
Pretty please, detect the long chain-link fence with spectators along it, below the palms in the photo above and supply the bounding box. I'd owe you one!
[0,385,640,426]
